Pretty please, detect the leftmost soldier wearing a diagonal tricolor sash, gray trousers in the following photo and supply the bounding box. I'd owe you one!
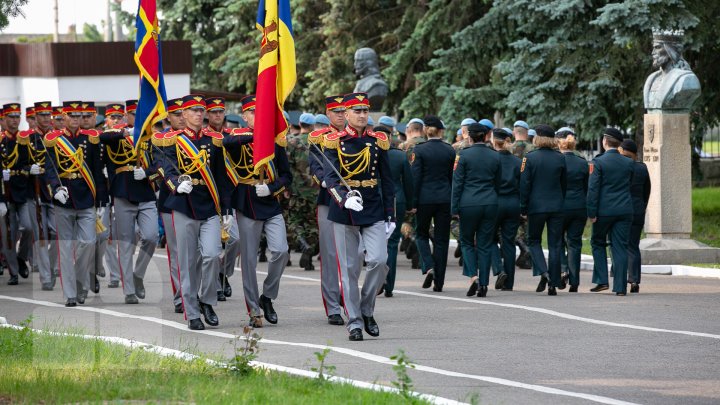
[44,101,107,306]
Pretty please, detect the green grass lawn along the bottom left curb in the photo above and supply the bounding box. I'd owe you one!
[0,328,424,404]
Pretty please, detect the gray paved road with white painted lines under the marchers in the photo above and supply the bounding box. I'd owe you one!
[0,254,720,405]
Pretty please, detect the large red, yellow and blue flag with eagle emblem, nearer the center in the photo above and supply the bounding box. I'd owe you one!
[253,0,297,173]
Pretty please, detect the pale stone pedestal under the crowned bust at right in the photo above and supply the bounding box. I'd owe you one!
[640,113,720,264]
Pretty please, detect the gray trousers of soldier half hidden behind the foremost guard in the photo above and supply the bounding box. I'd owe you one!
[317,205,342,316]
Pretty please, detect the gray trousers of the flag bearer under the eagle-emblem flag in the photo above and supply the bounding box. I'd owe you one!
[237,212,288,316]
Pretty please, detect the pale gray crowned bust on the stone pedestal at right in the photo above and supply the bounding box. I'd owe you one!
[643,30,700,112]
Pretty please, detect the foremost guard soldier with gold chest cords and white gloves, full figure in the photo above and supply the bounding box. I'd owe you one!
[323,93,395,341]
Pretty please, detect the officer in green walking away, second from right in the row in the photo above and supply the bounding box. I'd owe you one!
[588,128,635,295]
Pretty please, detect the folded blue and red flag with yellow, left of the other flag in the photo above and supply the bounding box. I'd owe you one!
[133,0,167,148]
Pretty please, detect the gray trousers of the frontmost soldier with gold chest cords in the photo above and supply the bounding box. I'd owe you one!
[333,221,388,331]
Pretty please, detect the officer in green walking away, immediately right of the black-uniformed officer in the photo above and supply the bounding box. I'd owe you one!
[450,124,502,297]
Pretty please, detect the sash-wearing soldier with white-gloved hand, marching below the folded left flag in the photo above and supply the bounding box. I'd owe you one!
[153,95,229,330]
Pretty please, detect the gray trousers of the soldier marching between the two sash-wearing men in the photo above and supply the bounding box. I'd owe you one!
[113,198,158,295]
